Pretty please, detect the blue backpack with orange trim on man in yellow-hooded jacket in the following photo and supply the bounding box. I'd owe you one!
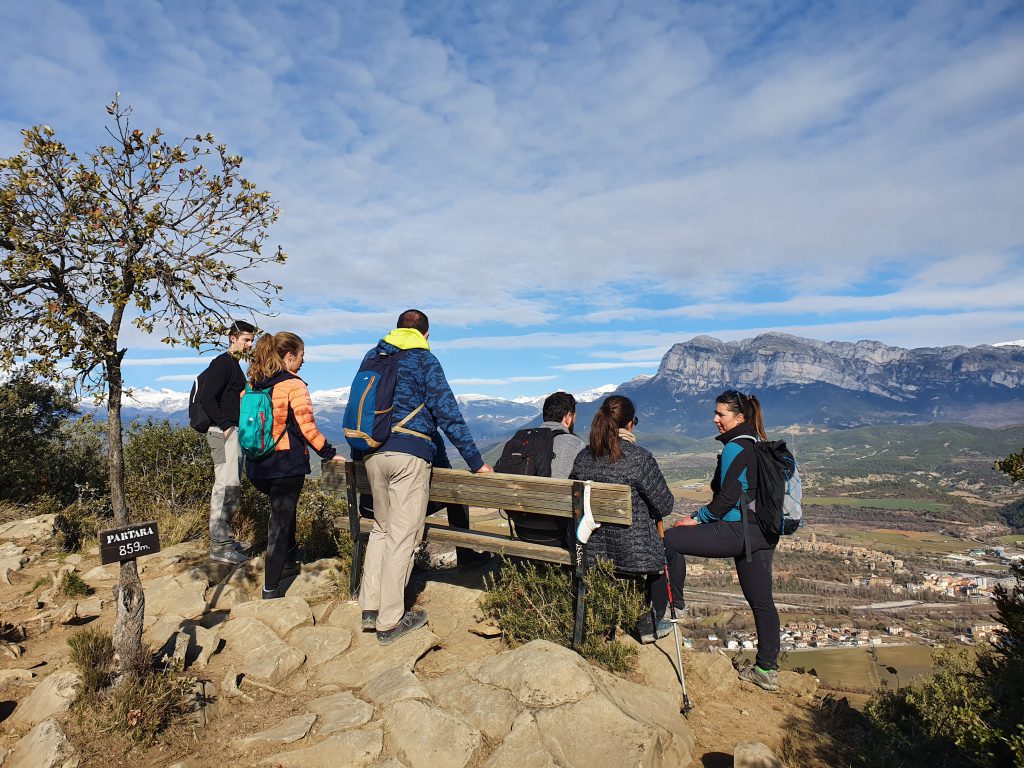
[341,349,429,452]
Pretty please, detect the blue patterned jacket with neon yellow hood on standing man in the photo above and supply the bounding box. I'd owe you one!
[352,328,483,472]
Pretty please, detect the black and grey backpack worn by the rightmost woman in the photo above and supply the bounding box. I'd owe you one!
[740,435,804,540]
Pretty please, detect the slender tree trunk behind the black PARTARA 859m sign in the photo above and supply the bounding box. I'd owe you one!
[106,355,147,678]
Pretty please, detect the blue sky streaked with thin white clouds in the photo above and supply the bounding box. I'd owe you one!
[0,0,1024,396]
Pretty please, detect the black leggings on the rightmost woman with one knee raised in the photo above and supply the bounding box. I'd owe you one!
[665,521,779,670]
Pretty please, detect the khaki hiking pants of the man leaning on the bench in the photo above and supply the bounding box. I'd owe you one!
[359,451,430,630]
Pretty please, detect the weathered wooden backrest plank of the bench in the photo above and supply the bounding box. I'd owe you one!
[324,462,633,525]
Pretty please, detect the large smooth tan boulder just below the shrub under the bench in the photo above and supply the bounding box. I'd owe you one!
[467,640,595,707]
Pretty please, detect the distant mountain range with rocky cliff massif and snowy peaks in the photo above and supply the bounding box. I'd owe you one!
[108,333,1024,442]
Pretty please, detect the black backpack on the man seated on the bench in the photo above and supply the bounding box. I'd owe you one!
[495,427,568,547]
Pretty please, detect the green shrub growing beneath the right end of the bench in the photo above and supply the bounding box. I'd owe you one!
[481,559,647,672]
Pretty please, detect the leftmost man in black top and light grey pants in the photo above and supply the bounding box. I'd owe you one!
[198,321,256,565]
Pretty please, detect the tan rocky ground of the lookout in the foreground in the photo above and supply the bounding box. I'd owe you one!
[0,518,817,768]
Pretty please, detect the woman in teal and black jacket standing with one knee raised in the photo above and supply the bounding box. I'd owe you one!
[665,389,779,691]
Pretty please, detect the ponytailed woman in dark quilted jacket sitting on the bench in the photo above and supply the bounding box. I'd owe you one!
[569,394,673,643]
